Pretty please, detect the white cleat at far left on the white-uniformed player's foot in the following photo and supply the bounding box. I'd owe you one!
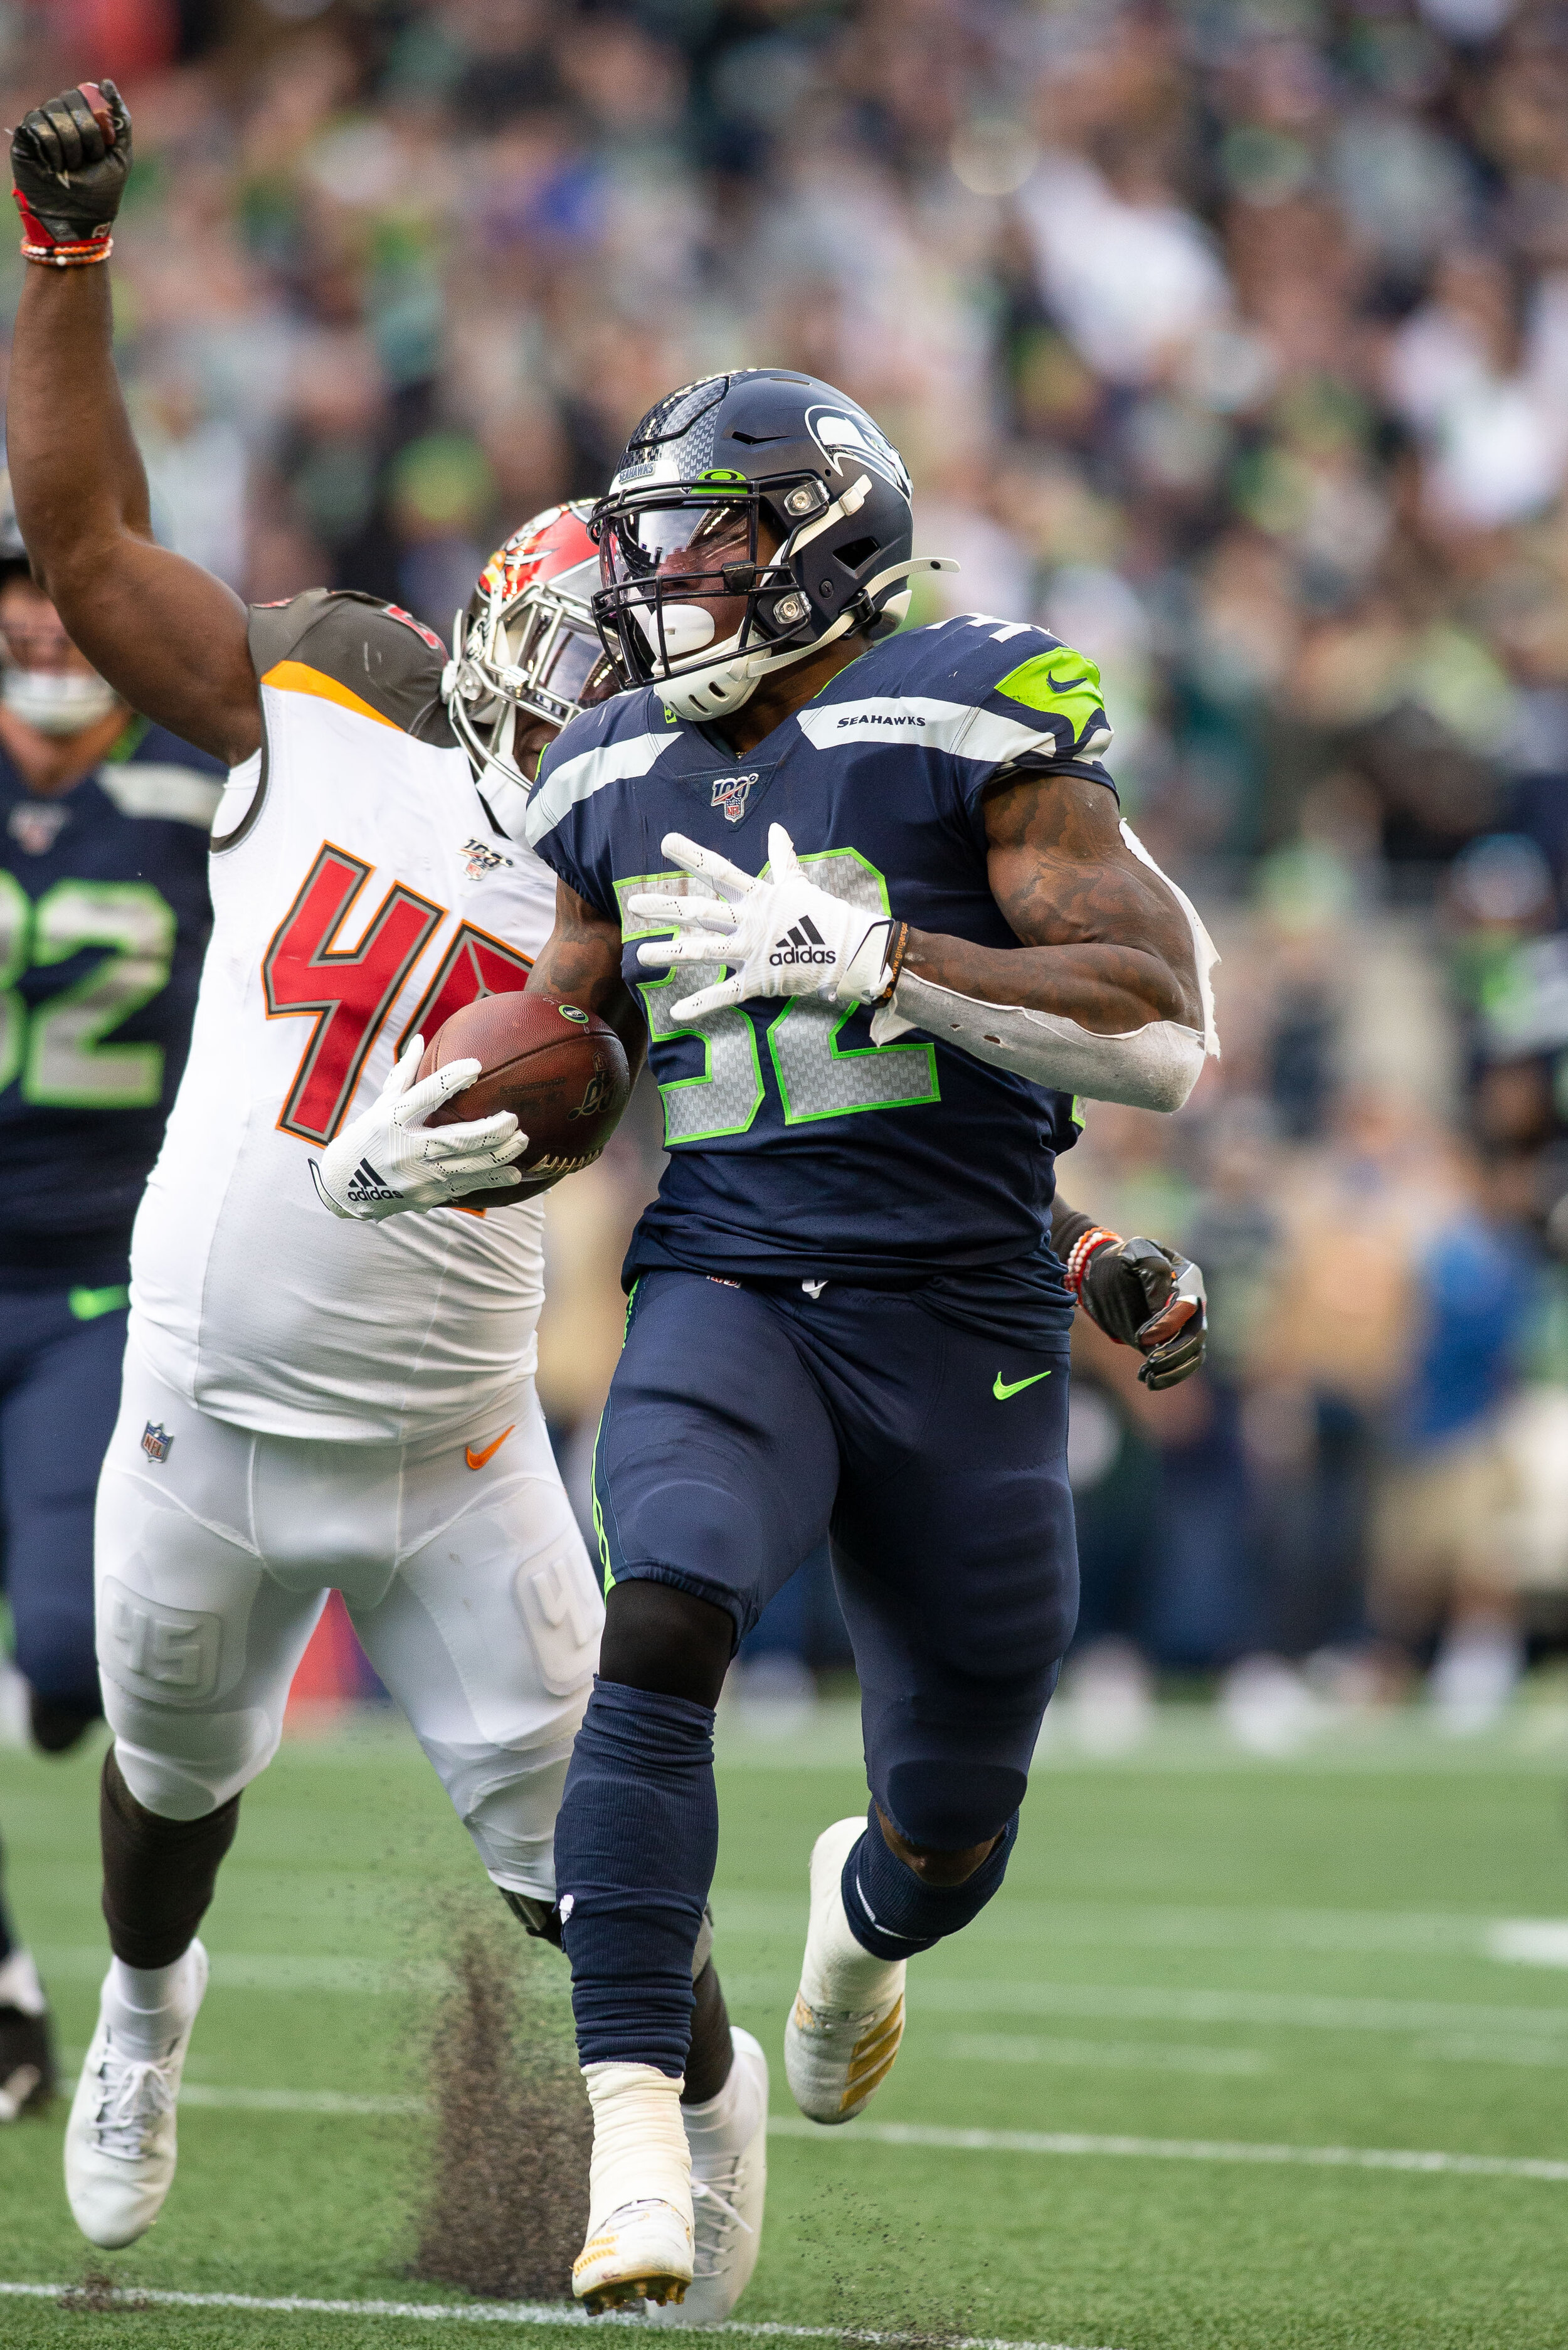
[66,1941,207,2252]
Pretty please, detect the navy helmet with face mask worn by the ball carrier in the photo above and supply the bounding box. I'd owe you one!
[588,367,956,719]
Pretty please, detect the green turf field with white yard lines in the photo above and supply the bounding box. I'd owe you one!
[0,1708,1568,2350]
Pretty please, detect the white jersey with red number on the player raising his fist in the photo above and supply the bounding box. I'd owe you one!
[132,590,555,1443]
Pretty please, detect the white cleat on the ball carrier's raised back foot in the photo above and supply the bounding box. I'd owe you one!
[785,1819,905,2122]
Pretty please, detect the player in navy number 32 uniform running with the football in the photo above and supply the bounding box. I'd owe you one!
[501,369,1218,2308]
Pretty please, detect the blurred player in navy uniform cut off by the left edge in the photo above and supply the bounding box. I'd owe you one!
[0,475,223,2120]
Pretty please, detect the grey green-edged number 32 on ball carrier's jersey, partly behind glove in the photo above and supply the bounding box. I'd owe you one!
[616,849,940,1149]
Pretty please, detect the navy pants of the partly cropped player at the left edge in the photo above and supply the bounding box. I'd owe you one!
[0,1290,127,1713]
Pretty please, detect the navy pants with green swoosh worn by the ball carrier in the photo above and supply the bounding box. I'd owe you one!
[595,1271,1077,1852]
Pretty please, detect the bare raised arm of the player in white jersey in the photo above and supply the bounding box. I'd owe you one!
[4,265,261,766]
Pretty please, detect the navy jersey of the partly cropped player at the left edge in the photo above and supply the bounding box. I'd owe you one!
[0,717,226,1283]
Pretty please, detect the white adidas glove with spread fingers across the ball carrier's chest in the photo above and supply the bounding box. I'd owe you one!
[628,825,893,1020]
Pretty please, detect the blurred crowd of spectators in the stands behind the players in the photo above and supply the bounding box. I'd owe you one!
[15,0,1568,1727]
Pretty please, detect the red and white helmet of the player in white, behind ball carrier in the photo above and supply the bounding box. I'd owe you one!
[442,505,616,792]
